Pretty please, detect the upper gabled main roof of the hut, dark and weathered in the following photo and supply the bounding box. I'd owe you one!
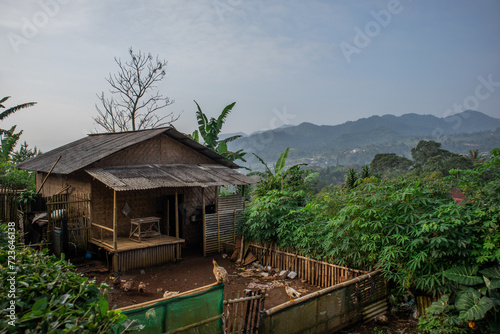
[16,127,239,174]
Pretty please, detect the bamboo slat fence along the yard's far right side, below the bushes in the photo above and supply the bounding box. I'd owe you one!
[249,244,366,288]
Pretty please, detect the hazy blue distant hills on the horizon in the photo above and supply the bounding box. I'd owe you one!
[229,110,500,169]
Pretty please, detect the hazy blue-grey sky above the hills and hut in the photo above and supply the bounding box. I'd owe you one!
[0,0,500,151]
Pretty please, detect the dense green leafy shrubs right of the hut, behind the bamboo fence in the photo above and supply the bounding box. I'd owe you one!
[243,150,500,294]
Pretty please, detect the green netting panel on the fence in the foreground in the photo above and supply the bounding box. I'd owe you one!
[123,284,224,334]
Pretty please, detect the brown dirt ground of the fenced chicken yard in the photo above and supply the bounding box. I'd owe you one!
[77,251,320,309]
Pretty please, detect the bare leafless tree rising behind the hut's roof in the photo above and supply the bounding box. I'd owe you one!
[93,48,179,132]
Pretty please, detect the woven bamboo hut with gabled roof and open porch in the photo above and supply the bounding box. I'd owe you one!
[17,127,255,271]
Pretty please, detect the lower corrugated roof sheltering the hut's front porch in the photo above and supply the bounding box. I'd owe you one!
[85,164,258,191]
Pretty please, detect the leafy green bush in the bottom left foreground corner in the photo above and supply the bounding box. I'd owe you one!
[0,225,138,333]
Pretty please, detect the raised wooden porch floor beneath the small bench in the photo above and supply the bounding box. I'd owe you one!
[90,235,185,253]
